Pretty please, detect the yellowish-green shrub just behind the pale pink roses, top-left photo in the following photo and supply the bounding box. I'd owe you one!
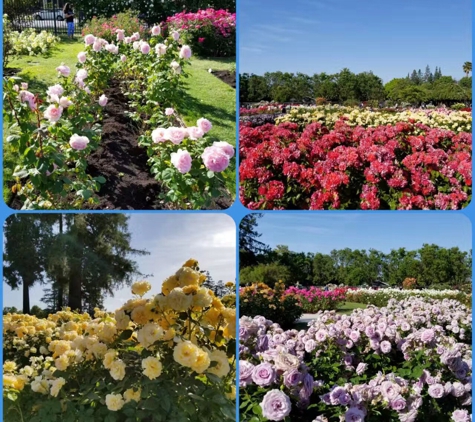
[82,10,146,42]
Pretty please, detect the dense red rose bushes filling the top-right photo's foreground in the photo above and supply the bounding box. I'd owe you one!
[239,119,472,210]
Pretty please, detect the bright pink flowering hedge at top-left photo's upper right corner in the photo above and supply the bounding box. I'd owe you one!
[167,8,236,57]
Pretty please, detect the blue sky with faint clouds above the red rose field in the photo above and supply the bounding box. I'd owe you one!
[239,0,472,82]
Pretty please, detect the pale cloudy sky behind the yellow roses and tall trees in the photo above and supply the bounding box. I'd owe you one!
[3,214,236,311]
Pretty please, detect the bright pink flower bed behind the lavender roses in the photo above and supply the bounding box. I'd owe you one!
[284,286,348,313]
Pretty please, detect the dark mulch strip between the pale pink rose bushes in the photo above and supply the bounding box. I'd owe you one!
[87,82,165,210]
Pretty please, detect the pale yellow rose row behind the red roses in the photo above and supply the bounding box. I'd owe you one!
[276,106,472,133]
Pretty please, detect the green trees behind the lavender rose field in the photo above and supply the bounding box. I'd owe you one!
[239,214,472,289]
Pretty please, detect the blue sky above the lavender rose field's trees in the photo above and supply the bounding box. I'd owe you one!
[257,211,472,253]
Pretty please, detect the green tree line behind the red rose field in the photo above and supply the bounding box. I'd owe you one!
[239,62,472,106]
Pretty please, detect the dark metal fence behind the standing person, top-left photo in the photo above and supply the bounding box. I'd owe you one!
[3,0,84,36]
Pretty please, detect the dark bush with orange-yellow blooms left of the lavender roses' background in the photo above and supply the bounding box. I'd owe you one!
[239,283,302,328]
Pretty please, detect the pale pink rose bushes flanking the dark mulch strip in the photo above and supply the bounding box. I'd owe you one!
[4,21,234,209]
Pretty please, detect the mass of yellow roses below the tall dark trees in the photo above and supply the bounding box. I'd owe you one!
[3,260,236,411]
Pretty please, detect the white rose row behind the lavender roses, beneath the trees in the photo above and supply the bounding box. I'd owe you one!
[346,288,472,308]
